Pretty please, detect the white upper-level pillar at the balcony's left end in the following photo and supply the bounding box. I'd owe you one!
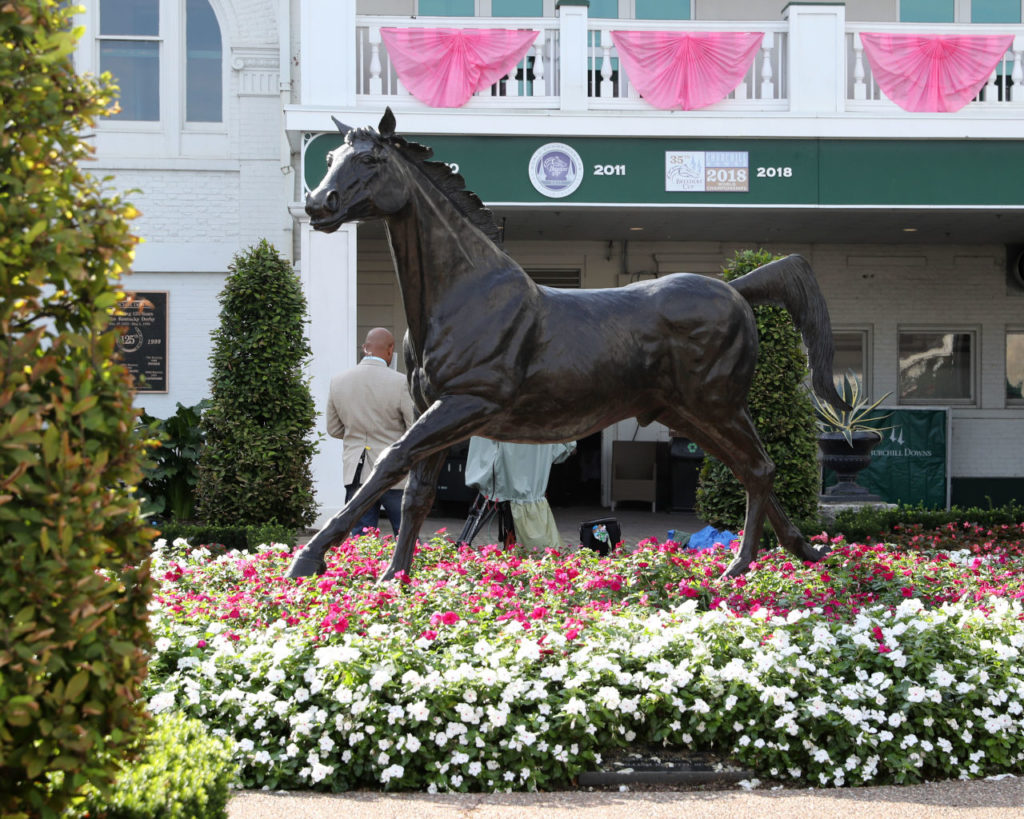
[299,0,355,109]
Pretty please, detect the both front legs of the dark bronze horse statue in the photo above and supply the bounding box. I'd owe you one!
[287,395,497,577]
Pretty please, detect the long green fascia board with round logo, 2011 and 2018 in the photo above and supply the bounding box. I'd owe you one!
[302,133,1024,208]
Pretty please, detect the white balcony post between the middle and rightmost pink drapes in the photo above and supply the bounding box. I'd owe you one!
[782,4,846,114]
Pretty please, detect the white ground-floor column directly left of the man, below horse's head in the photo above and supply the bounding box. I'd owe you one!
[300,218,357,525]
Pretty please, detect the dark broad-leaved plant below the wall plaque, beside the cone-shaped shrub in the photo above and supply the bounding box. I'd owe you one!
[138,401,209,520]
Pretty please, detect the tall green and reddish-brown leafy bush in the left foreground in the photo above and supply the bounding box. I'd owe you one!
[0,0,153,816]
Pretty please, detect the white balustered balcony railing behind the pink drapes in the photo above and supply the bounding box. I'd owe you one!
[346,15,1024,116]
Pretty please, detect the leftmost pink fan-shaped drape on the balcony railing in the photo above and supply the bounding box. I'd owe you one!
[381,29,539,109]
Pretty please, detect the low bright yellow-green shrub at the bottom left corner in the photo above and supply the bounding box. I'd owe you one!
[77,714,234,819]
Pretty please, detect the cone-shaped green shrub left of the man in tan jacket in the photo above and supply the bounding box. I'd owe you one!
[196,240,316,527]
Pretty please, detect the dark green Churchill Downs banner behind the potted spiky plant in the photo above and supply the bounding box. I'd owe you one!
[825,408,949,509]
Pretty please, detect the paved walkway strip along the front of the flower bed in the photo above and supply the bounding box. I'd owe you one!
[227,778,1024,819]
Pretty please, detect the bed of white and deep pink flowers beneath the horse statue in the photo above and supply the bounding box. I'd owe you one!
[147,526,1024,790]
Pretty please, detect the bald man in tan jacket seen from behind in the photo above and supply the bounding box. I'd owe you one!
[327,327,415,535]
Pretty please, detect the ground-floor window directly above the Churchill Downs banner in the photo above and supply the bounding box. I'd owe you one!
[898,330,976,404]
